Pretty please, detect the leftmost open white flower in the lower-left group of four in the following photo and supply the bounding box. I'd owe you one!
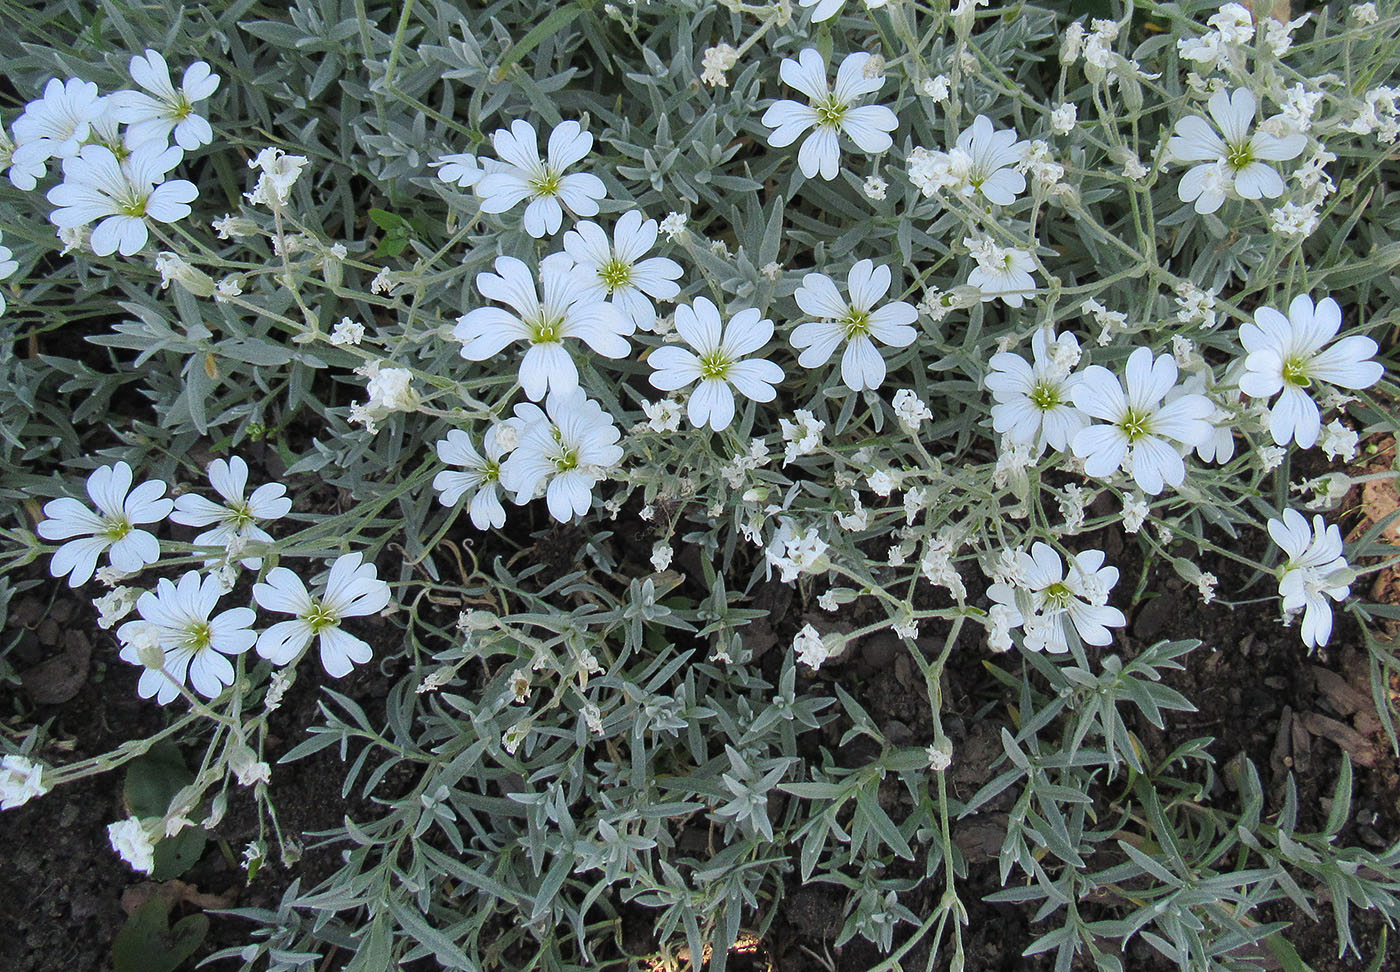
[38,462,175,587]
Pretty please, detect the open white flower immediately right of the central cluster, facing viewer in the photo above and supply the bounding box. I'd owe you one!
[791,261,918,391]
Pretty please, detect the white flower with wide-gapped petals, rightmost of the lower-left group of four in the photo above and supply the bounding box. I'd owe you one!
[253,553,391,678]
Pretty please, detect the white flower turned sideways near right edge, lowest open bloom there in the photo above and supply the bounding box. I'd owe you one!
[1268,510,1351,648]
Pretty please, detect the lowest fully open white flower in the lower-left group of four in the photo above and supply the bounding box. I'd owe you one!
[116,570,258,706]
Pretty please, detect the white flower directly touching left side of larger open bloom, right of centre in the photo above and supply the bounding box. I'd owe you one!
[987,326,1089,457]
